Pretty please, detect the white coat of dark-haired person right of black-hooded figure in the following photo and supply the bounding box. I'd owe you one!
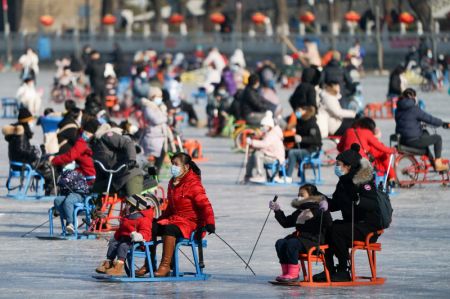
[318,90,356,136]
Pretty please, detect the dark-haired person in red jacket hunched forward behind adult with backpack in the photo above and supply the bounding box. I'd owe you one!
[337,117,396,185]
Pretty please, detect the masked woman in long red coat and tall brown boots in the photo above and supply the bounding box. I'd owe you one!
[136,153,215,277]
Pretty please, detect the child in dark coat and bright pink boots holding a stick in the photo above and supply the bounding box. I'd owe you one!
[269,184,332,282]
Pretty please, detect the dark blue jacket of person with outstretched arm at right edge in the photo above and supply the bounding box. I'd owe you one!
[395,98,442,141]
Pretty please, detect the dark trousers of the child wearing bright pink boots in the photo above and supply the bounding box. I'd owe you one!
[275,238,317,265]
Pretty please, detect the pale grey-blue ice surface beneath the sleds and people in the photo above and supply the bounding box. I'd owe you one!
[0,70,450,298]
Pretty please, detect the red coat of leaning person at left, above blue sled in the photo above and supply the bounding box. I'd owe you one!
[52,137,95,182]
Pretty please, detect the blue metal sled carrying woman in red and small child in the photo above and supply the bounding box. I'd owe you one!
[93,232,210,282]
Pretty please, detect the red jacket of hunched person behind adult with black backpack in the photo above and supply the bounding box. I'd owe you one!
[337,128,394,158]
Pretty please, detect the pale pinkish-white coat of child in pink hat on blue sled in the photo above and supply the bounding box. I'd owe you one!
[252,126,285,163]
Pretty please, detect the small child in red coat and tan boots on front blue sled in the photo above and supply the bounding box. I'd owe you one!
[95,195,153,276]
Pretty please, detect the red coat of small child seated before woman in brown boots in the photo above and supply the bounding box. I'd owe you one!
[114,208,153,241]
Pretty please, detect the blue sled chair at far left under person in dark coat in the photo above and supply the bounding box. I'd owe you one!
[6,161,44,199]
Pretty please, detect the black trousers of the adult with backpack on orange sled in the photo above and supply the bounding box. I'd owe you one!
[325,220,378,269]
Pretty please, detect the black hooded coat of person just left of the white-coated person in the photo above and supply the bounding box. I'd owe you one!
[289,68,320,111]
